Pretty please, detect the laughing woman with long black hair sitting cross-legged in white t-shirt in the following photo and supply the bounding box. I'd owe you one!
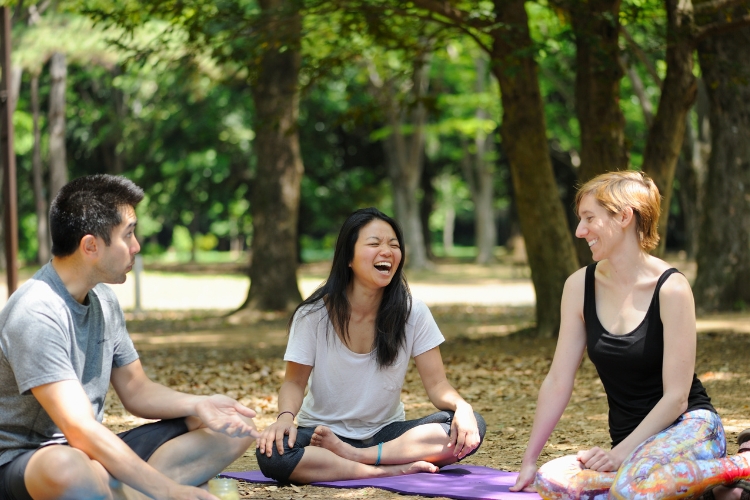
[256,208,485,484]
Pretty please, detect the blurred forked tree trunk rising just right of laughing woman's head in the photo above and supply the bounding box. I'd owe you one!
[371,53,430,269]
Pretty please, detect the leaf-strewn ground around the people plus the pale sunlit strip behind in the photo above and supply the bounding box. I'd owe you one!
[0,256,750,500]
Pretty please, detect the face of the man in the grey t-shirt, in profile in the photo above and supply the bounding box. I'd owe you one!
[97,206,141,284]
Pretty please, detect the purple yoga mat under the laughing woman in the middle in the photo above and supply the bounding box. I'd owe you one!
[221,465,541,500]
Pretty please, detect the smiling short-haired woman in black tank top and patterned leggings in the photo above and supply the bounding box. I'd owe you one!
[511,172,750,500]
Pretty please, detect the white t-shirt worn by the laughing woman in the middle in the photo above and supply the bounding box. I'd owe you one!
[284,299,445,439]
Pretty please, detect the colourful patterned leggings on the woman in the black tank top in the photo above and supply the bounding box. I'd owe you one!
[535,410,750,500]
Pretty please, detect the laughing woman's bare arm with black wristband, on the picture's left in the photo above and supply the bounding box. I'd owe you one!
[257,361,312,457]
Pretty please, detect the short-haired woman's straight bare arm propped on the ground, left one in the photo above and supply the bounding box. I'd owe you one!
[511,269,586,491]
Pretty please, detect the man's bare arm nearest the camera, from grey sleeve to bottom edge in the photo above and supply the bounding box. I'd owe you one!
[31,380,216,500]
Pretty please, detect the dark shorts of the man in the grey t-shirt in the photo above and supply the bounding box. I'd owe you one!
[0,418,188,500]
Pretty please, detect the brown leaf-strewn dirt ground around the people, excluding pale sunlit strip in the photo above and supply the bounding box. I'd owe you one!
[105,305,750,500]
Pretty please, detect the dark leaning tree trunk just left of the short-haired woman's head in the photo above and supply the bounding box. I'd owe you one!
[491,0,578,337]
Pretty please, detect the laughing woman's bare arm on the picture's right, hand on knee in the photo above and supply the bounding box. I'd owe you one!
[414,347,481,459]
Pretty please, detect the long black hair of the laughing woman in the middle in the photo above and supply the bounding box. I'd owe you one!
[288,208,411,368]
